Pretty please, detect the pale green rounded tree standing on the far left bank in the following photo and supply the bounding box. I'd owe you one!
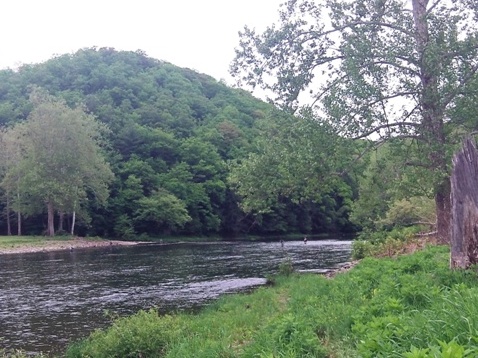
[7,89,113,236]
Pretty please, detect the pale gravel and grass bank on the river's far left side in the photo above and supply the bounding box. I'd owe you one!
[0,236,141,255]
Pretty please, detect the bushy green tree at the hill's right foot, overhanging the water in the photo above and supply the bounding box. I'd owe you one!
[229,107,360,227]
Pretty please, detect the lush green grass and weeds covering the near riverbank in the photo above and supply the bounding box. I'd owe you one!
[66,247,478,358]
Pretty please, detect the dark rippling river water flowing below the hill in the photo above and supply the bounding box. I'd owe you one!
[0,240,350,354]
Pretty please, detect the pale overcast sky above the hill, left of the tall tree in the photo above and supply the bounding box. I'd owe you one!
[0,0,283,82]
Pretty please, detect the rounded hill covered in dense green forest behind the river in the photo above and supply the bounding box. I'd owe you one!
[0,48,355,238]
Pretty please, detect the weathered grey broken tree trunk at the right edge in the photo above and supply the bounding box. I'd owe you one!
[450,138,478,268]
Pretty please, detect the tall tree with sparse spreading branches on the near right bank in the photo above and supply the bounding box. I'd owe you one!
[231,0,478,240]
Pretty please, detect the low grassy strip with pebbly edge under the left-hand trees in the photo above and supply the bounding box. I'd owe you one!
[0,237,142,255]
